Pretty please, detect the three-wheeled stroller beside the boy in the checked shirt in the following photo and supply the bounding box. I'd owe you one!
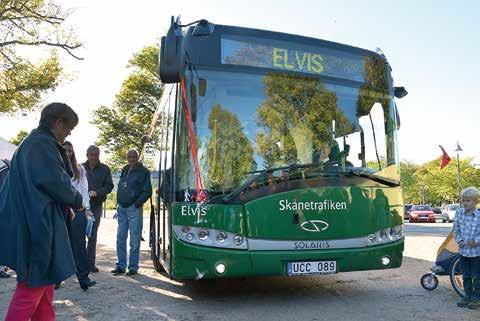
[420,231,465,298]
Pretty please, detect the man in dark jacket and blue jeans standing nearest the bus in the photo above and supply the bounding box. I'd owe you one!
[112,150,152,275]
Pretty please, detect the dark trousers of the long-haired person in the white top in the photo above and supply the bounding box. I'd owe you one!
[70,212,89,282]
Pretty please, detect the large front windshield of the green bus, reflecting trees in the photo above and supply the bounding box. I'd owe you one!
[176,69,398,194]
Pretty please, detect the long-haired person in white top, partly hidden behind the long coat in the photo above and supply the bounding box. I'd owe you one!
[63,141,96,290]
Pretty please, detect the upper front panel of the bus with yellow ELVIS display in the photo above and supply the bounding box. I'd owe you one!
[182,21,389,83]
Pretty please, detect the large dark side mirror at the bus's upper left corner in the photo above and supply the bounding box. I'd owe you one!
[160,16,183,84]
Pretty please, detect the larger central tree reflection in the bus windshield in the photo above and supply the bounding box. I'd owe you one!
[256,73,354,167]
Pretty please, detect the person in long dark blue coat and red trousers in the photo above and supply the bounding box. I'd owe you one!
[0,103,82,321]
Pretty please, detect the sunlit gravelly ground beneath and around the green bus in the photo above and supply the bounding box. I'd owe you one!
[0,218,480,321]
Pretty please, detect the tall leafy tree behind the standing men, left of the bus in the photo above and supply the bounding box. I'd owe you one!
[91,46,163,169]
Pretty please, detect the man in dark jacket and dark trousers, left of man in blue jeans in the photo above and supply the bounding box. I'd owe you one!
[83,145,113,273]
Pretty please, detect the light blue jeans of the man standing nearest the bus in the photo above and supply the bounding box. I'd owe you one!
[117,205,143,271]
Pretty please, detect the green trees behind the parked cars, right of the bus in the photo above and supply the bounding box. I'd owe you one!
[401,158,480,204]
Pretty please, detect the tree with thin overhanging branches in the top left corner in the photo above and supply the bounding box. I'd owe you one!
[0,0,82,113]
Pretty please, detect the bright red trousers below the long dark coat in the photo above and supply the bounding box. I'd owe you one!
[5,283,55,321]
